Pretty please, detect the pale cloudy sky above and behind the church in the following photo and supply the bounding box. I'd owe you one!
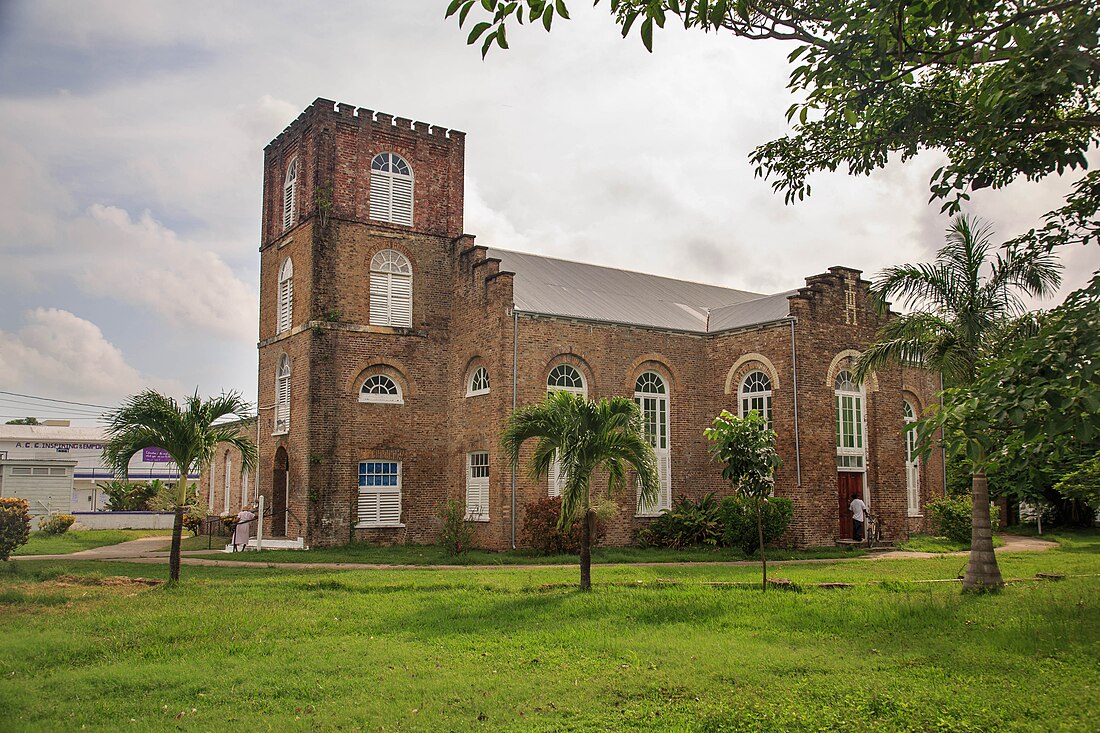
[0,0,1100,419]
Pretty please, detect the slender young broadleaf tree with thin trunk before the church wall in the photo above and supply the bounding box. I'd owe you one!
[703,409,782,590]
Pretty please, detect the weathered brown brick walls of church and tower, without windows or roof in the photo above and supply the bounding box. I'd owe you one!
[212,99,943,549]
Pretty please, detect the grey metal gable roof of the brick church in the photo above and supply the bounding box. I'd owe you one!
[487,248,793,333]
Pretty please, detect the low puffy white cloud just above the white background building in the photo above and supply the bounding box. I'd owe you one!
[0,308,180,404]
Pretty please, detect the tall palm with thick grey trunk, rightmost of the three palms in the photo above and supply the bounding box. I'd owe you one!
[856,216,1062,589]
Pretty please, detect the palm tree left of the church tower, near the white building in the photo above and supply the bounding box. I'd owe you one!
[103,390,256,582]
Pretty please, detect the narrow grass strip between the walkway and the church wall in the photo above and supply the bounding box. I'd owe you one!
[173,537,866,566]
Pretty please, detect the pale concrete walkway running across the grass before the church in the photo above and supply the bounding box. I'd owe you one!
[12,535,1058,570]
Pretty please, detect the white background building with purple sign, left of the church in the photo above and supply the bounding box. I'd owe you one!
[0,420,199,515]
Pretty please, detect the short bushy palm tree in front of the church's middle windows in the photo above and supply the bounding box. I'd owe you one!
[501,392,660,590]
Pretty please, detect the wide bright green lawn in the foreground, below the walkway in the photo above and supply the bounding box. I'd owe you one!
[0,533,1100,733]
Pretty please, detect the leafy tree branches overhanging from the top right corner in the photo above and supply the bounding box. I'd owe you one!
[448,0,1100,248]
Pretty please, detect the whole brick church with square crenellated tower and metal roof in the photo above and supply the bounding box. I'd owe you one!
[207,99,944,549]
